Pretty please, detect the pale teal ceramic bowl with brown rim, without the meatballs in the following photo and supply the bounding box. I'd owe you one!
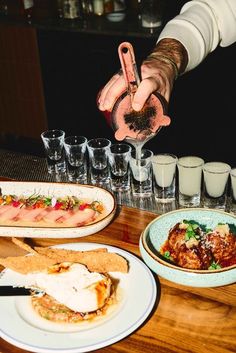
[139,208,236,287]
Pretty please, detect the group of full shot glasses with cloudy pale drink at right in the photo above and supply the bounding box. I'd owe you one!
[152,153,236,214]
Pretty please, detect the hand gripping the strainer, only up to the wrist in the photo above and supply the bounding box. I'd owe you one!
[98,57,176,111]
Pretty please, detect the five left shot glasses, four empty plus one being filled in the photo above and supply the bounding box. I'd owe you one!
[41,130,153,196]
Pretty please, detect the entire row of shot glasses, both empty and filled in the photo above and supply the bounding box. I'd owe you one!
[41,130,236,214]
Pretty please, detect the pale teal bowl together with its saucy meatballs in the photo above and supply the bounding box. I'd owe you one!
[139,208,236,287]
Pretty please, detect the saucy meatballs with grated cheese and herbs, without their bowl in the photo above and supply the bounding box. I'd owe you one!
[160,220,236,270]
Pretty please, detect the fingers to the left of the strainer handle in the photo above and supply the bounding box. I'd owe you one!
[98,73,126,111]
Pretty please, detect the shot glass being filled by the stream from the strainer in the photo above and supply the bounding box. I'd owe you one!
[130,149,153,197]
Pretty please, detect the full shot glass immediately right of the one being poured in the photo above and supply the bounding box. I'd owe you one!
[152,153,178,203]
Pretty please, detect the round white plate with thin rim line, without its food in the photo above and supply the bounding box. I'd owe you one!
[0,243,157,353]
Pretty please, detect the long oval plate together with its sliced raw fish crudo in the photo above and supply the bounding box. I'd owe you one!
[0,181,116,238]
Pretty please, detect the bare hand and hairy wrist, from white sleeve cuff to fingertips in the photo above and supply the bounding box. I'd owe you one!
[98,38,188,111]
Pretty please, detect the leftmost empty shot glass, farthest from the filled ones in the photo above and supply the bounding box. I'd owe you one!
[41,129,66,174]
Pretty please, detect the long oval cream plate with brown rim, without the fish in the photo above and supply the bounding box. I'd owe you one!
[0,181,116,238]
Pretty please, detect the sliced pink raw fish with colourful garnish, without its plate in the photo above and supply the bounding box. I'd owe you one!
[0,194,105,227]
